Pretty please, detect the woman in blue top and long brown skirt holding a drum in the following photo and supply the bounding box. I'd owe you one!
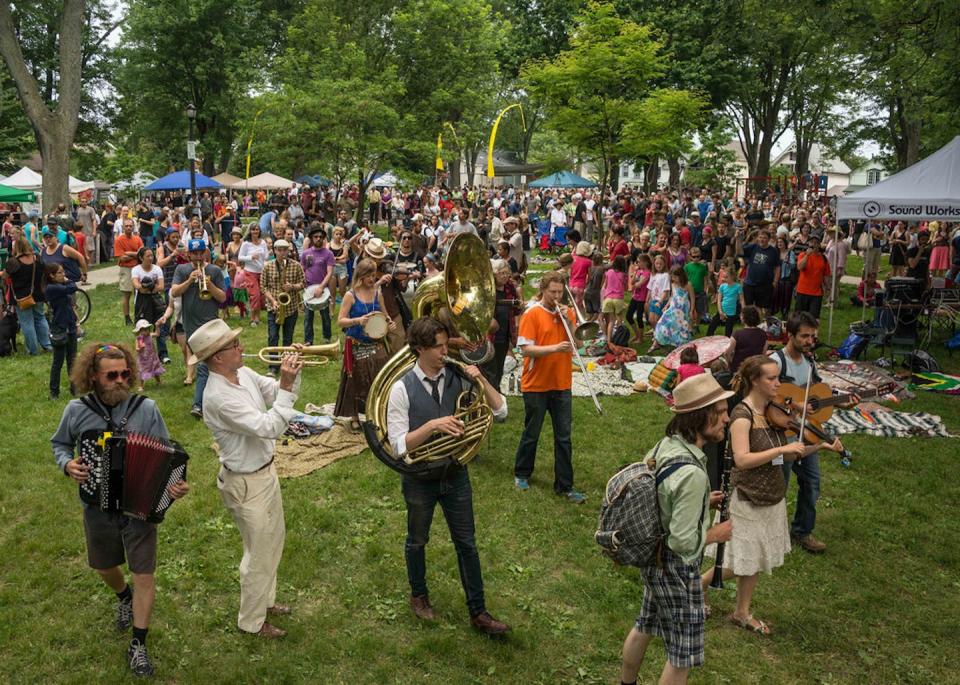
[334,259,396,431]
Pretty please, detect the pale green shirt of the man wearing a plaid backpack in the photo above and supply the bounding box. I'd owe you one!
[644,435,710,564]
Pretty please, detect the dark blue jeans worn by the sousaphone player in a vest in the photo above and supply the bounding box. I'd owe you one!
[401,468,486,616]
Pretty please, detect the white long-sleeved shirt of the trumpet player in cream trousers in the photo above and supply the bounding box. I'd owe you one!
[203,367,300,473]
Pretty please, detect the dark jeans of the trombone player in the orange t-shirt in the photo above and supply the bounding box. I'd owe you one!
[513,390,573,493]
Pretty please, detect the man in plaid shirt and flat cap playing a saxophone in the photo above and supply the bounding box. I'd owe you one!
[260,240,306,375]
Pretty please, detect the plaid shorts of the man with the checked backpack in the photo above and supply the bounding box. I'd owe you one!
[636,546,706,668]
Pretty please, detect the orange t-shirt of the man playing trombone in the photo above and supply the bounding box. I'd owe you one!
[517,304,576,392]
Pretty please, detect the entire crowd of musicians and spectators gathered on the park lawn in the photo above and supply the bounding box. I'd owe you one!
[3,176,960,683]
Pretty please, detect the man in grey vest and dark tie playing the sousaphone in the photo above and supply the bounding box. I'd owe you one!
[387,317,510,635]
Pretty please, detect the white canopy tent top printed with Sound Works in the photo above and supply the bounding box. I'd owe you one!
[837,136,960,221]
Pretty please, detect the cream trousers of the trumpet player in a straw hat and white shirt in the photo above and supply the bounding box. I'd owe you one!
[217,465,285,633]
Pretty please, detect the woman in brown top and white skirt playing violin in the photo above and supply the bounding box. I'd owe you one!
[702,355,843,635]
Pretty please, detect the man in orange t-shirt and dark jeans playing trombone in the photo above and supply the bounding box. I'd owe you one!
[513,271,586,504]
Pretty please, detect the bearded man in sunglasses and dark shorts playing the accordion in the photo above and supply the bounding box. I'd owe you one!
[50,344,190,676]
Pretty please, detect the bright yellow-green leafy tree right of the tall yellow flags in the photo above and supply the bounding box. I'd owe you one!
[523,2,700,191]
